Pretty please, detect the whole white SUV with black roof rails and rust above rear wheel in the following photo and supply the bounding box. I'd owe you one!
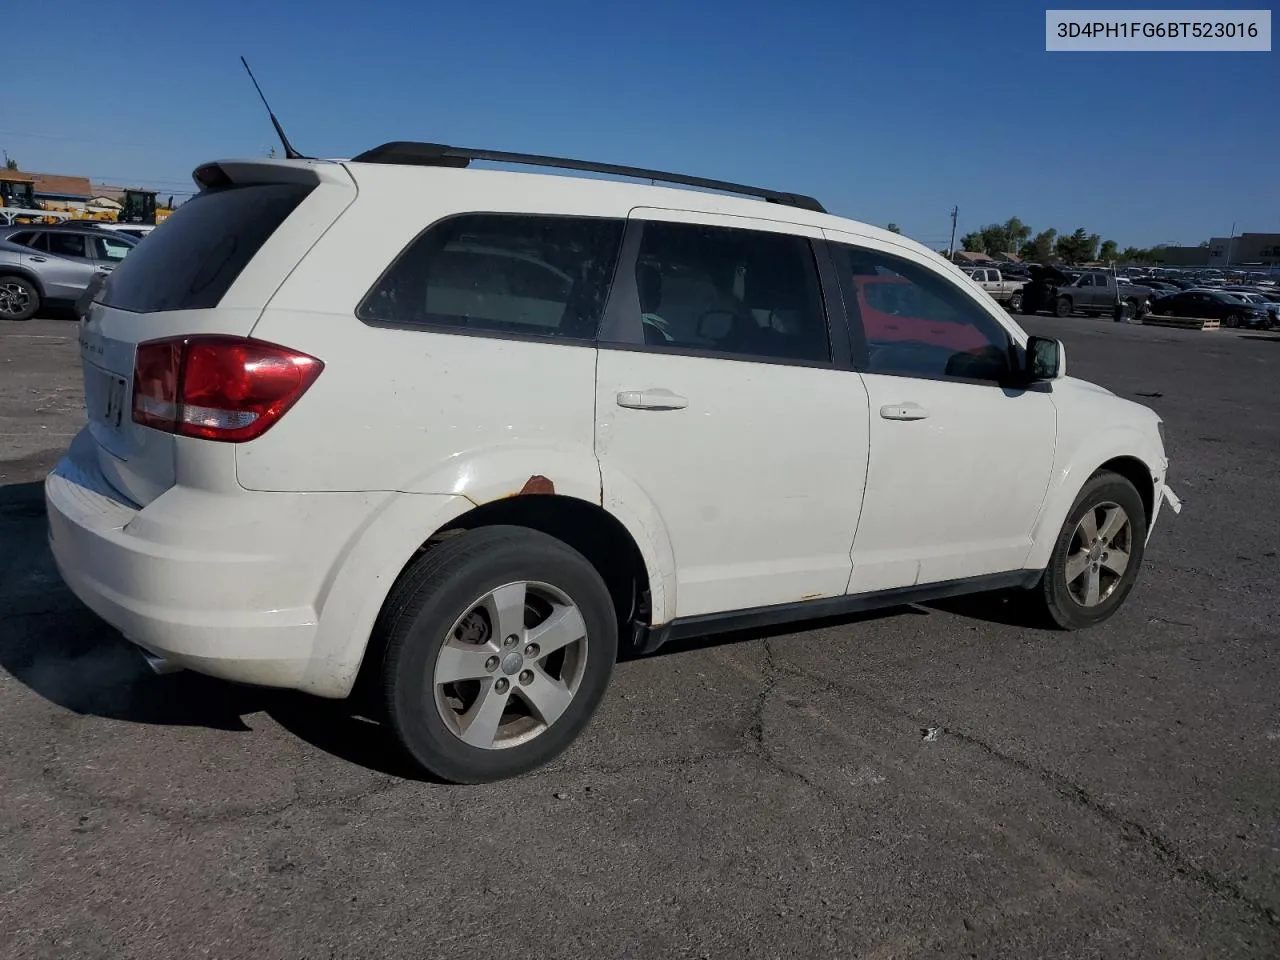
[45,143,1179,782]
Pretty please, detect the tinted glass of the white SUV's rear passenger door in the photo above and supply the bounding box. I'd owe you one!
[632,220,831,362]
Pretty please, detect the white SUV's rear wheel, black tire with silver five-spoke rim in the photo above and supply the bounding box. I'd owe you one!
[370,526,618,783]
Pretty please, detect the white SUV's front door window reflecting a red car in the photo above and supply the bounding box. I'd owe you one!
[832,243,1011,381]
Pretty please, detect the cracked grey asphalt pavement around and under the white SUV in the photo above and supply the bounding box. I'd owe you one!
[0,319,1280,960]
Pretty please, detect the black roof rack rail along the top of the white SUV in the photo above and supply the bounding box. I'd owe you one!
[352,140,827,214]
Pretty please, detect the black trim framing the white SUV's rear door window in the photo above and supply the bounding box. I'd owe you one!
[599,216,854,371]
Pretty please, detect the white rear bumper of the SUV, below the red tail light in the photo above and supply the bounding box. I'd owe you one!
[45,429,381,692]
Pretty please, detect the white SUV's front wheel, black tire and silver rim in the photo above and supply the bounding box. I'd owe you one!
[1030,470,1147,630]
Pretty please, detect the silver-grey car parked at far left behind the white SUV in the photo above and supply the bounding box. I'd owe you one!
[0,225,138,320]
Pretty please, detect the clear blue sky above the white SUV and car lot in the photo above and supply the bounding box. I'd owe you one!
[0,0,1280,246]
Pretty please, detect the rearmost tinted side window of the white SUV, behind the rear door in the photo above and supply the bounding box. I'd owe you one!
[356,214,623,340]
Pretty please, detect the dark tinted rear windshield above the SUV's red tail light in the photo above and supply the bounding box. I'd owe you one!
[99,183,315,314]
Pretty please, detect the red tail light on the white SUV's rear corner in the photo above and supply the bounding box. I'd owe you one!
[133,335,324,443]
